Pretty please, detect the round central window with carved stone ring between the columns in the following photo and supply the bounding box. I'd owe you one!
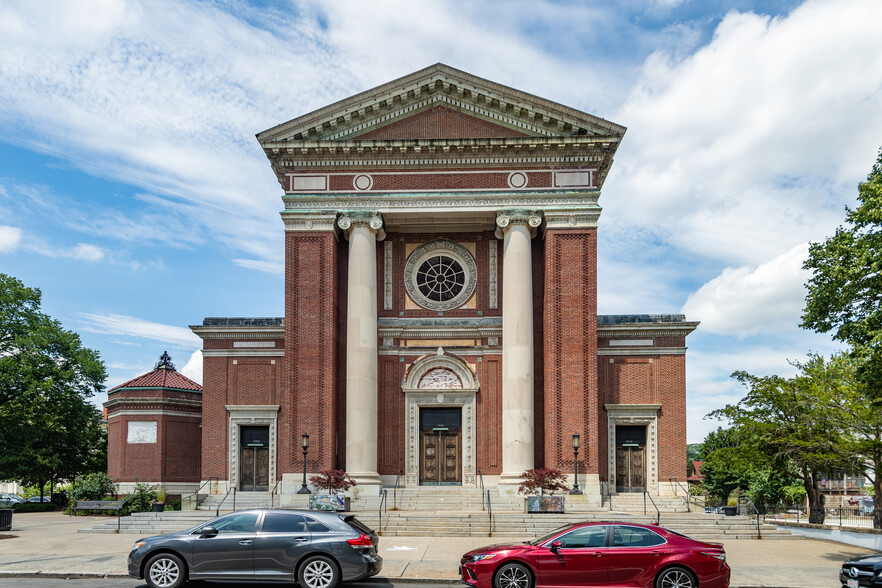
[404,239,478,311]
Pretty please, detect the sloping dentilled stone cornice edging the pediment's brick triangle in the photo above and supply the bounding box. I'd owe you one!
[257,63,626,145]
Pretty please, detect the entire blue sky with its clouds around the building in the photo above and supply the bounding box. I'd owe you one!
[0,0,882,442]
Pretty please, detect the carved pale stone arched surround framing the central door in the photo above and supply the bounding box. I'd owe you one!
[401,348,480,487]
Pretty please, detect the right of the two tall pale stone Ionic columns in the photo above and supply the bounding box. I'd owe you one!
[496,210,542,493]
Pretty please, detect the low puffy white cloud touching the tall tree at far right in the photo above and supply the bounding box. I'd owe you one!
[683,243,811,337]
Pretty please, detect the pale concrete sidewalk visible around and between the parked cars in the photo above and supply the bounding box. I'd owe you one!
[0,513,869,588]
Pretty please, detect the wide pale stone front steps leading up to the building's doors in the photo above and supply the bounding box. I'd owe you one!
[80,486,796,541]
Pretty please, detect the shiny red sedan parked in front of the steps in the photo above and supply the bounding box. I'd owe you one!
[460,523,729,588]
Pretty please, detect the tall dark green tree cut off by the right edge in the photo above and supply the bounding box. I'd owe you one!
[802,150,882,399]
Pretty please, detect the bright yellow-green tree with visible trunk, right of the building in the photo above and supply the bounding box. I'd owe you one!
[709,356,853,523]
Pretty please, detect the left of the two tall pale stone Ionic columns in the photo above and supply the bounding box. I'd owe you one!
[337,213,386,494]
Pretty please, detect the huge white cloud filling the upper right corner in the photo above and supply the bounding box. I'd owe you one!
[604,0,882,264]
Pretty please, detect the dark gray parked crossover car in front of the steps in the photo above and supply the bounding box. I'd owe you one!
[129,510,383,588]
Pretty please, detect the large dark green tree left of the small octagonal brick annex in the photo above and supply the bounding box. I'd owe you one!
[0,274,107,494]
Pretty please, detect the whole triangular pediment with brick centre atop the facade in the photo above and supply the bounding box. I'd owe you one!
[257,63,625,148]
